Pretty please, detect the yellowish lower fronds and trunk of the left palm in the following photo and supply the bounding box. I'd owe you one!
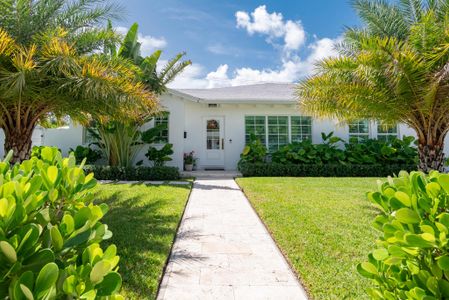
[0,28,157,161]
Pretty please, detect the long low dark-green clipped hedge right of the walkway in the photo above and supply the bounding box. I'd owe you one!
[239,163,416,177]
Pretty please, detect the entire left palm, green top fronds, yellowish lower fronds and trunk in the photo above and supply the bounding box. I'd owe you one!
[0,0,156,161]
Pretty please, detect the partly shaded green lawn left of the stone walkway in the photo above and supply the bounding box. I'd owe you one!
[96,184,191,299]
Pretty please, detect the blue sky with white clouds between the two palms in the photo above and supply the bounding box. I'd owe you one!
[116,0,358,88]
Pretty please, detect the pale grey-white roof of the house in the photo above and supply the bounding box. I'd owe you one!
[176,83,295,103]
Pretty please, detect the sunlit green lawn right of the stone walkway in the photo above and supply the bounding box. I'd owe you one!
[237,178,378,299]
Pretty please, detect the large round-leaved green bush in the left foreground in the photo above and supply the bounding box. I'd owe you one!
[0,147,123,300]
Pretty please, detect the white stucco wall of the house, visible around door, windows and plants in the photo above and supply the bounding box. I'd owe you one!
[0,94,449,170]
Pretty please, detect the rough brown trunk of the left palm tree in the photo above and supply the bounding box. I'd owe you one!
[3,127,34,163]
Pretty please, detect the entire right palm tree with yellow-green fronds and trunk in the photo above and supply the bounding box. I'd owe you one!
[297,0,449,172]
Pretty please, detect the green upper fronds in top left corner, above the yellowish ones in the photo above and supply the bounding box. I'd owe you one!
[0,0,123,54]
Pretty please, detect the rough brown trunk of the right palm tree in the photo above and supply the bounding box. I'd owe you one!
[418,141,445,173]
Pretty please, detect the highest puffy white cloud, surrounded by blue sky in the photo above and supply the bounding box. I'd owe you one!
[235,5,306,51]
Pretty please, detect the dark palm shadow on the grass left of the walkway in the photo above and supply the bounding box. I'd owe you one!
[94,190,189,299]
